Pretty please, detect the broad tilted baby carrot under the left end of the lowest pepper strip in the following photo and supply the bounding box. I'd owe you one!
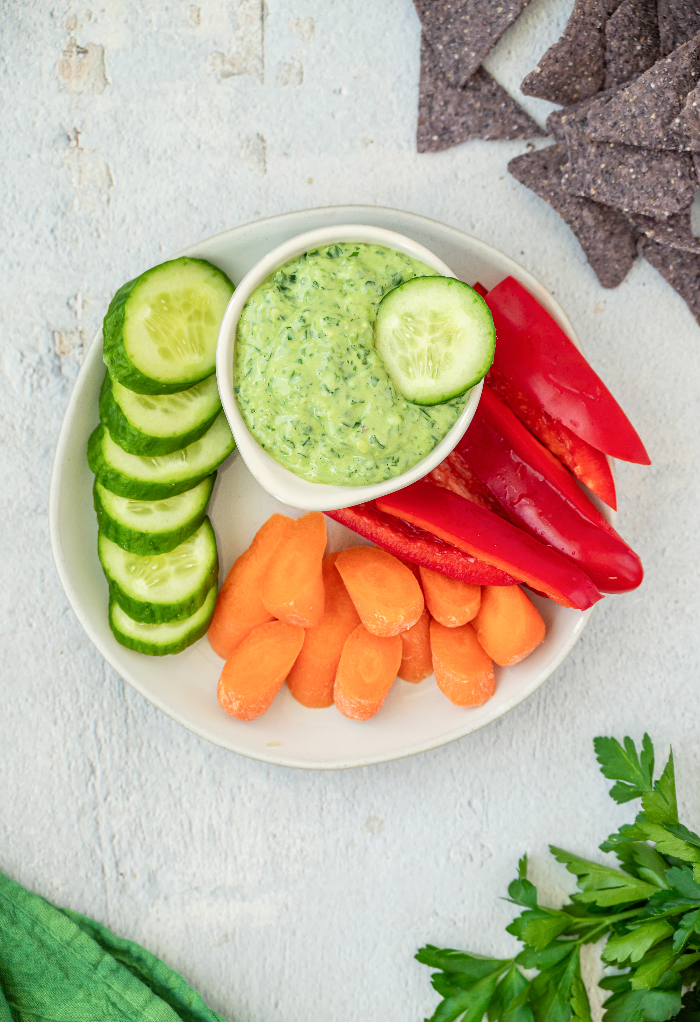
[335,547,424,637]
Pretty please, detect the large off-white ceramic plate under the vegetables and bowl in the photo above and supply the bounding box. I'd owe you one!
[49,206,612,770]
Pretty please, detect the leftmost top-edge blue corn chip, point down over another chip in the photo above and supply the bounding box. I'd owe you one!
[413,0,530,88]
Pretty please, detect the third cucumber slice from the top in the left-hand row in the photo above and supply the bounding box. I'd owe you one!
[88,412,236,501]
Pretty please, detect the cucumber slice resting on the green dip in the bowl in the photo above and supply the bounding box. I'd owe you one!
[374,277,496,405]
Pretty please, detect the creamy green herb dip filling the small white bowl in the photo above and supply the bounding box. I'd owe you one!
[234,242,469,485]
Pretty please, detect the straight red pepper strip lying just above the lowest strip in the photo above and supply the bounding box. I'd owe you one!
[377,481,602,610]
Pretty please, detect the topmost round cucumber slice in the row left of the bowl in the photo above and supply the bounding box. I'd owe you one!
[103,257,233,393]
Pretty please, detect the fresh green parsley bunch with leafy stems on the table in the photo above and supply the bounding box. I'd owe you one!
[416,735,700,1022]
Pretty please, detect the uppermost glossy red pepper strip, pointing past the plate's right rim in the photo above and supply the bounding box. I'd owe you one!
[485,277,651,465]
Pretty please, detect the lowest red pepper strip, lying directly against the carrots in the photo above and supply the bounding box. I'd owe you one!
[326,500,518,586]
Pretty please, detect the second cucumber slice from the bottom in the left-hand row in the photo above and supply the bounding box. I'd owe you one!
[97,518,219,624]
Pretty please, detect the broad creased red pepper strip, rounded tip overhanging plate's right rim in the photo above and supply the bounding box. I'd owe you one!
[457,386,644,593]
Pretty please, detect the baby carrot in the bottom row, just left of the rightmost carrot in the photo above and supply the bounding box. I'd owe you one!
[430,617,494,706]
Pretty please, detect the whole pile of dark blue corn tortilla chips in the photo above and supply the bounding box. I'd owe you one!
[414,0,700,322]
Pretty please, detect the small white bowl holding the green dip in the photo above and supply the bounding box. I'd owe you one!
[217,224,483,511]
